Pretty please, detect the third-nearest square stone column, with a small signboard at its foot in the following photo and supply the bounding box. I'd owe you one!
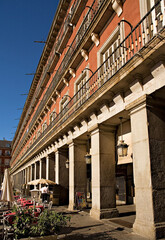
[69,140,87,210]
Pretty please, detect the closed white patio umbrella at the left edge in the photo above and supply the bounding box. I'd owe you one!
[1,169,14,202]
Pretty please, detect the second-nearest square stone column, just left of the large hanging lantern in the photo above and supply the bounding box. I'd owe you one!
[90,125,118,219]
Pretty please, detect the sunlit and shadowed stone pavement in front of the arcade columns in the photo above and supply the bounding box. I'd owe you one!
[53,207,146,240]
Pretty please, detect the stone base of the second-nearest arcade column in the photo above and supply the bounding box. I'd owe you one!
[90,208,119,220]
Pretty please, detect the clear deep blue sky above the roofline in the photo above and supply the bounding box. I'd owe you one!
[0,0,59,141]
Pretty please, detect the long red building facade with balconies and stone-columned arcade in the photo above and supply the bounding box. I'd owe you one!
[11,0,165,239]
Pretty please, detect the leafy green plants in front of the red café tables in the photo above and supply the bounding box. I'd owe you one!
[13,205,70,240]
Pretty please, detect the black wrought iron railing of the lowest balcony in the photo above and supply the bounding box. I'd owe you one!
[11,0,165,165]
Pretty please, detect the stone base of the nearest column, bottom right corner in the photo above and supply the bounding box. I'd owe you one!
[133,220,165,240]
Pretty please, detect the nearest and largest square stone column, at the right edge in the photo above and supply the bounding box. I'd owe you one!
[127,96,165,239]
